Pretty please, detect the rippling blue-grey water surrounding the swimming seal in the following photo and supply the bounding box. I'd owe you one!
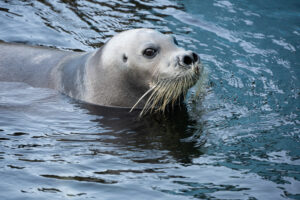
[0,0,300,200]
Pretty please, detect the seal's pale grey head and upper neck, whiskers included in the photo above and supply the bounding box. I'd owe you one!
[81,29,202,115]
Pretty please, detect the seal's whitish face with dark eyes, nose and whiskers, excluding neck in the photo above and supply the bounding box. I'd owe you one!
[103,29,201,113]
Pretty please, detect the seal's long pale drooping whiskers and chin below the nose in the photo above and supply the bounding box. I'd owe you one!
[131,63,201,116]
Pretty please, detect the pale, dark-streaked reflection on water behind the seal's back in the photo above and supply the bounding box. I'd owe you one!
[0,0,182,50]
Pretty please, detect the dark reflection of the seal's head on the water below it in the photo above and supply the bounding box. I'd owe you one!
[79,104,202,164]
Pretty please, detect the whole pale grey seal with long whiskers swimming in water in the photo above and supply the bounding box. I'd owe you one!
[0,29,202,115]
